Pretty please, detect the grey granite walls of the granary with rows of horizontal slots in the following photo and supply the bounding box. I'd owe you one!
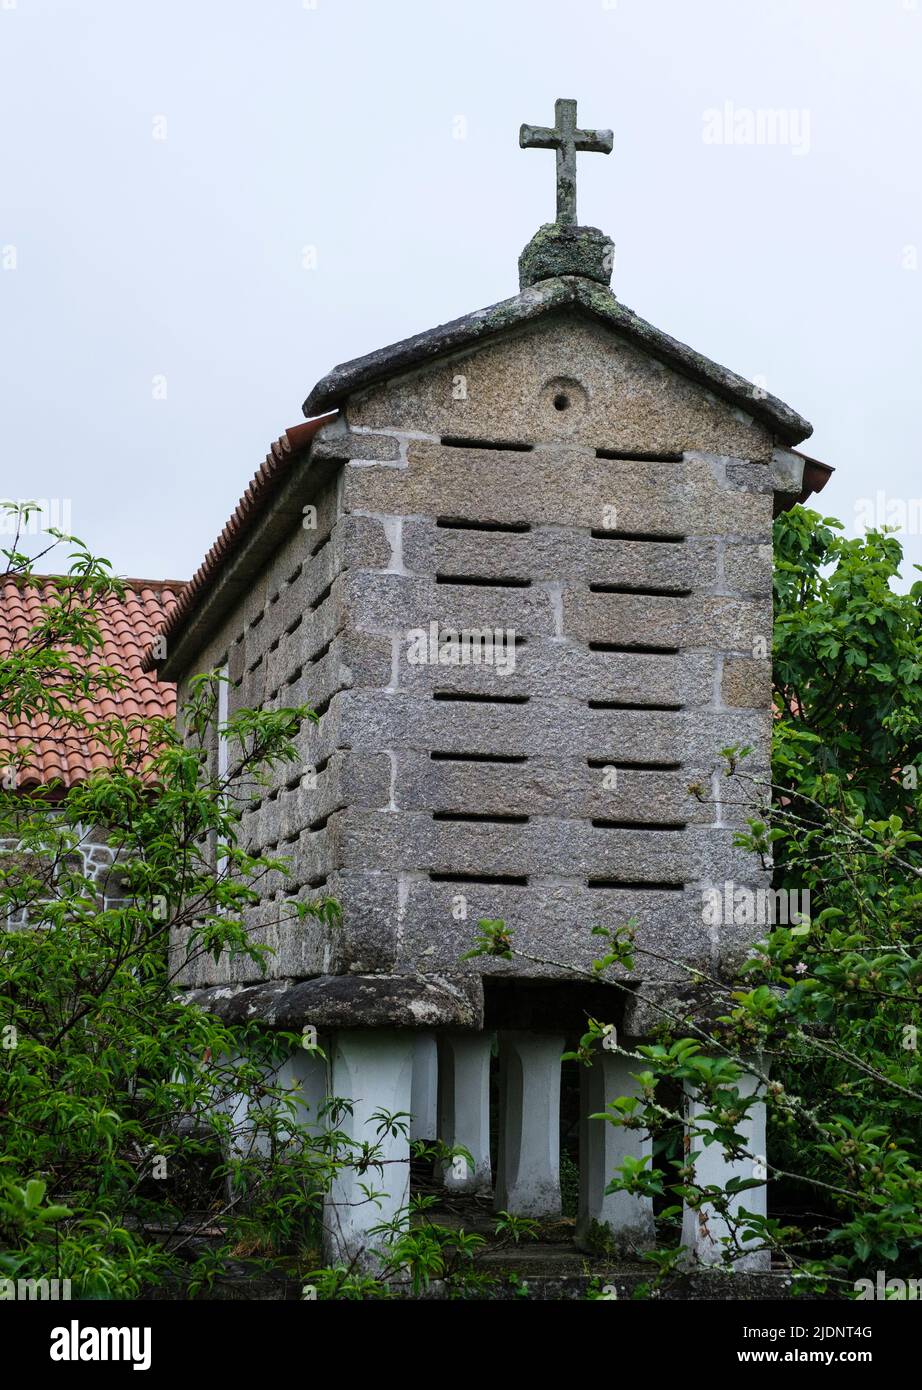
[171,309,775,1023]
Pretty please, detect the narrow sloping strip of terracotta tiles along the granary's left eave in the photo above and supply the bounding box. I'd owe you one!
[143,410,338,671]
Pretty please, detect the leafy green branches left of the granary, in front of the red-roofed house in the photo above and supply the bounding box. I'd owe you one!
[0,517,475,1298]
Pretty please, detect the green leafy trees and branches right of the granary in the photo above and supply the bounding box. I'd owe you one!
[473,509,922,1297]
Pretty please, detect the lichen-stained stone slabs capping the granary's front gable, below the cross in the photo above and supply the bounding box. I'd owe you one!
[303,275,814,445]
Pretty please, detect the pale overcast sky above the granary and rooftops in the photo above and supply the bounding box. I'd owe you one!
[0,0,922,578]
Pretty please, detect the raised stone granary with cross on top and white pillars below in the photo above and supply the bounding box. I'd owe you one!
[152,101,830,1259]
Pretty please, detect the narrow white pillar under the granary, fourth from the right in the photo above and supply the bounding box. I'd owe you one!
[438,1033,492,1193]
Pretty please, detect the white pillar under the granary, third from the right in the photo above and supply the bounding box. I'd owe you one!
[495,1033,565,1216]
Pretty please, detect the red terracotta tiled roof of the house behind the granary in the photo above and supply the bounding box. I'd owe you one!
[0,575,185,788]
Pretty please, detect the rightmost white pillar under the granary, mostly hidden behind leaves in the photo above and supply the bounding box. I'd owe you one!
[681,1068,772,1270]
